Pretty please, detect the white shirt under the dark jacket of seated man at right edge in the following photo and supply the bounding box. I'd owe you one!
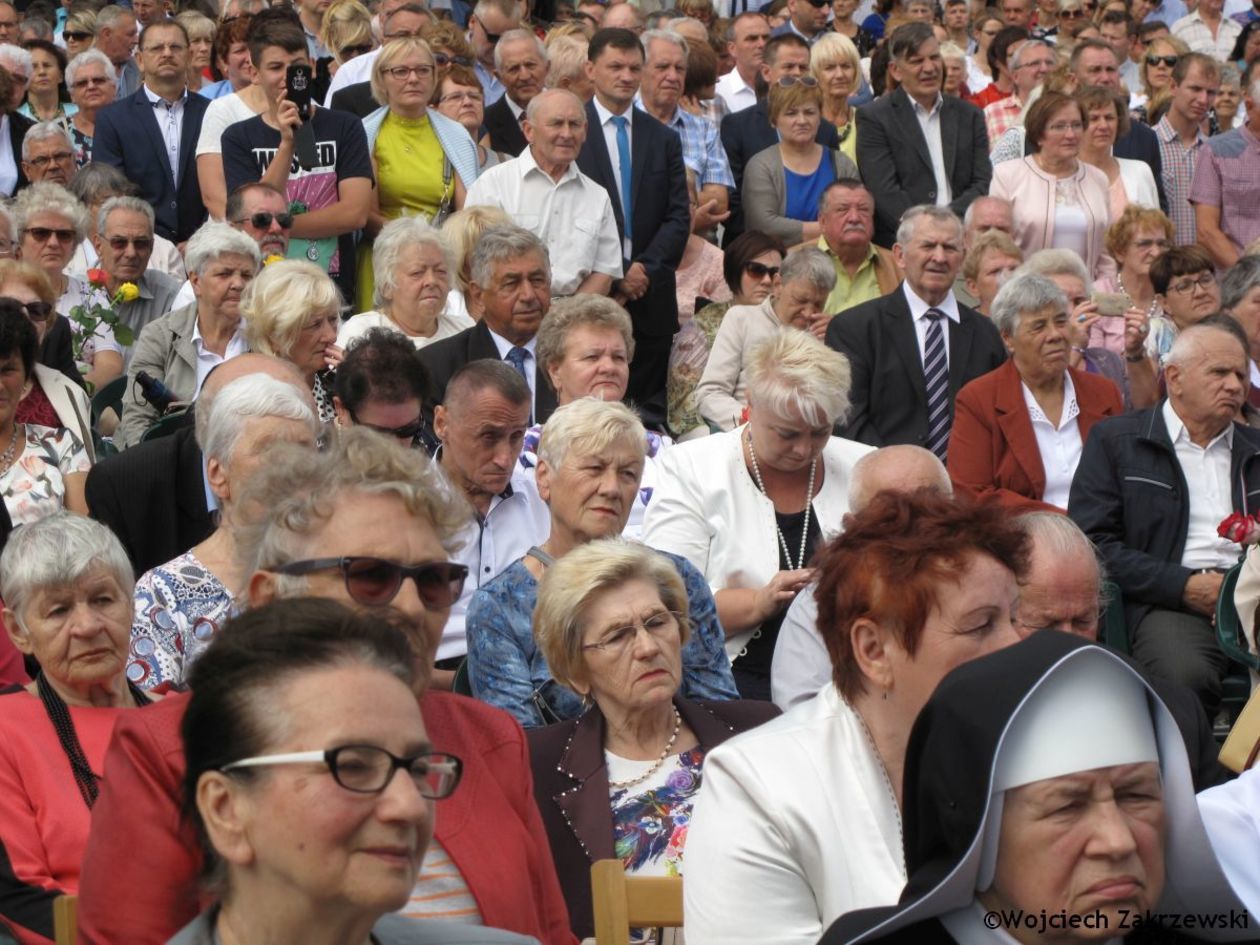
[1163,401,1239,568]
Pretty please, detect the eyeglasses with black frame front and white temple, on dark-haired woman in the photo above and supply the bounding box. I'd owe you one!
[219,745,464,800]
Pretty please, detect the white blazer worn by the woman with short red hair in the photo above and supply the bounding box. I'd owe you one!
[683,685,906,945]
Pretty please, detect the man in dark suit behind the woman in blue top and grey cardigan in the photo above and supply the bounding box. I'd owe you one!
[721,33,840,246]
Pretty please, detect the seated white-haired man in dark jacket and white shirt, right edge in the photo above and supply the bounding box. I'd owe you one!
[1067,324,1260,718]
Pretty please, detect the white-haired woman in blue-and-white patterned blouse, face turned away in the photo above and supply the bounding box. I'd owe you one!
[127,374,319,689]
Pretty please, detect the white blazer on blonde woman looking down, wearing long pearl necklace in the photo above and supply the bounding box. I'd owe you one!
[643,426,874,660]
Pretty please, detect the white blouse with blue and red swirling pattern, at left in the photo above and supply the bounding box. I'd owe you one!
[127,552,234,689]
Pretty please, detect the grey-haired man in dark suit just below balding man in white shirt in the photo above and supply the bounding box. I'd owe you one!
[420,227,556,423]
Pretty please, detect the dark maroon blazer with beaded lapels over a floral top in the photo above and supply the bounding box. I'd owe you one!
[525,697,779,939]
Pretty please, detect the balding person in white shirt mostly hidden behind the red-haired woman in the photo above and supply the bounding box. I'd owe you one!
[770,445,954,712]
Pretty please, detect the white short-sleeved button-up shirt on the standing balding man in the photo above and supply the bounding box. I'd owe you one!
[464,148,622,296]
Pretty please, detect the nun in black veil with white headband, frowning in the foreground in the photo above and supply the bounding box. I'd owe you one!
[819,630,1260,945]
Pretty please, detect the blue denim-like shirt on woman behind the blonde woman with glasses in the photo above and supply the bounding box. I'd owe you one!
[466,552,740,728]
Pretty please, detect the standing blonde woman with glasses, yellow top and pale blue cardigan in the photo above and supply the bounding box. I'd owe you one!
[357,39,480,311]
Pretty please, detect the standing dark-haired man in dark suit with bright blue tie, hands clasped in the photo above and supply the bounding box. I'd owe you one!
[577,29,690,404]
